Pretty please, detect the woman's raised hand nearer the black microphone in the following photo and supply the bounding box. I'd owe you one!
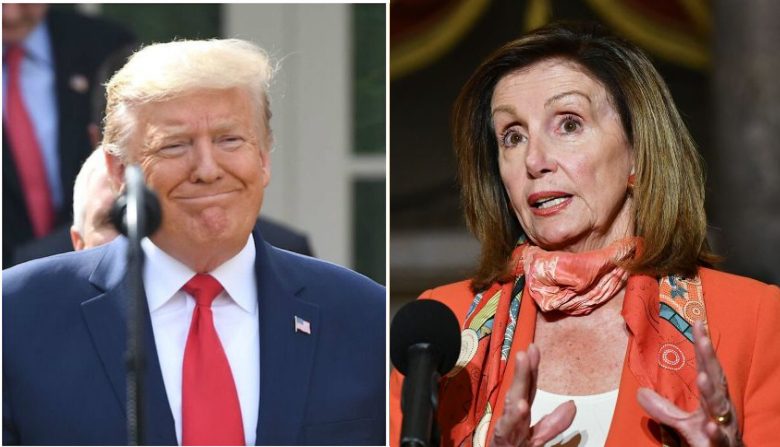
[491,344,577,447]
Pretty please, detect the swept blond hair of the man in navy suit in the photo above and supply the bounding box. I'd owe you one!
[102,39,276,160]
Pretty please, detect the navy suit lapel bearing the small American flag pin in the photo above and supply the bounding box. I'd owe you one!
[254,232,320,445]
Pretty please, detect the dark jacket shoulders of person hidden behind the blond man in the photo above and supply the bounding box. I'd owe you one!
[11,217,314,265]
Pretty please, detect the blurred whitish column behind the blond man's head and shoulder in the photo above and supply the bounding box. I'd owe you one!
[223,4,352,266]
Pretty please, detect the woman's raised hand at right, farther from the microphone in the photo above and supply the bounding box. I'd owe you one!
[637,323,743,447]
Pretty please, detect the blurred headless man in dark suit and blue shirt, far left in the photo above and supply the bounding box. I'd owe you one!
[2,3,135,267]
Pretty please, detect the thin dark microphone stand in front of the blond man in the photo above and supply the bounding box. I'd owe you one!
[125,165,146,445]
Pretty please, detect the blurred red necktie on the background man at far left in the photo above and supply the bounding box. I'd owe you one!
[5,46,54,237]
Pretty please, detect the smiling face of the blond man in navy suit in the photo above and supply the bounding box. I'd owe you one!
[111,88,270,272]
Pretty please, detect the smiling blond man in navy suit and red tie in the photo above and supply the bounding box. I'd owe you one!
[3,40,387,445]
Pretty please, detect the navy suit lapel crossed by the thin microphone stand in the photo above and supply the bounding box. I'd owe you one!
[81,237,176,445]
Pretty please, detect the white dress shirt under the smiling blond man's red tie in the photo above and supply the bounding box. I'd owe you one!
[142,235,260,445]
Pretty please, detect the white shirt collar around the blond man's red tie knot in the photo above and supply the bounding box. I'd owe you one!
[141,234,257,314]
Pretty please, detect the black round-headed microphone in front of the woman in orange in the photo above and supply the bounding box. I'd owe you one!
[390,299,460,447]
